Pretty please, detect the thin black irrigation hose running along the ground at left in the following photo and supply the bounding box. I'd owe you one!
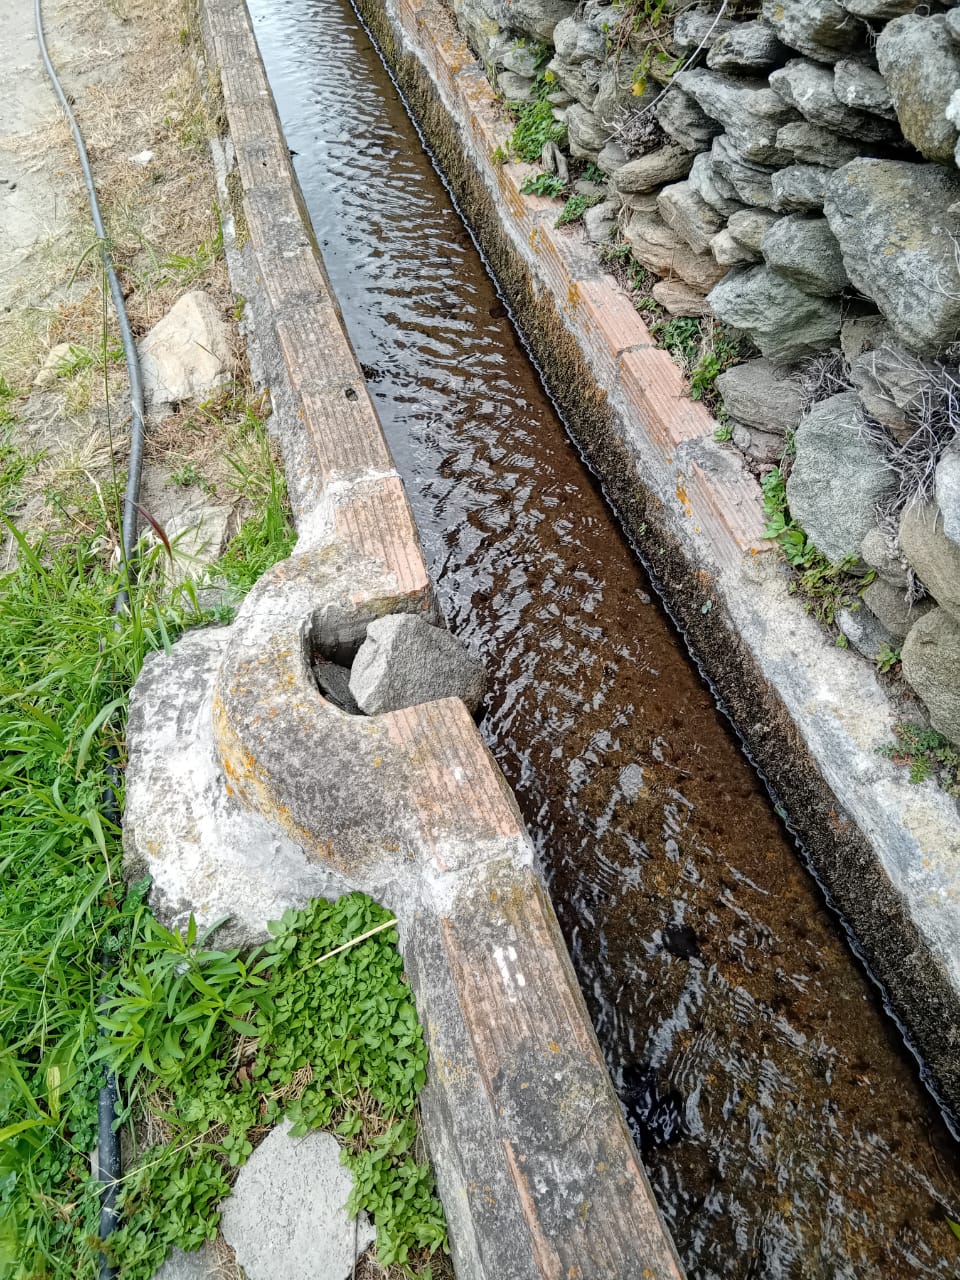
[33,0,143,1280]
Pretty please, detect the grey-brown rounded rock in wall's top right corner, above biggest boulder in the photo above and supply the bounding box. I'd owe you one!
[877,13,960,163]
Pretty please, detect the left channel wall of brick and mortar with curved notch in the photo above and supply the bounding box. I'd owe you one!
[124,0,682,1280]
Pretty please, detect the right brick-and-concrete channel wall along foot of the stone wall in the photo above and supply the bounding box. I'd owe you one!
[343,0,960,1112]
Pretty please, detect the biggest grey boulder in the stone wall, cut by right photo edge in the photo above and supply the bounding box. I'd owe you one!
[823,160,960,352]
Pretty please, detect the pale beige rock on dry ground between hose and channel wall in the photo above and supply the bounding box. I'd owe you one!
[140,289,232,411]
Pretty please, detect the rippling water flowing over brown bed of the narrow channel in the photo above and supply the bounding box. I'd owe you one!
[244,0,960,1280]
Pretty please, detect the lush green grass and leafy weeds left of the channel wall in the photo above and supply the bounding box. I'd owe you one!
[0,383,445,1280]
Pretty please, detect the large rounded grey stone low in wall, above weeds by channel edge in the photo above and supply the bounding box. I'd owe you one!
[787,392,895,563]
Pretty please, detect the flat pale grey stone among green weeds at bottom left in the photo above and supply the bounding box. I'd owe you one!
[220,1124,376,1280]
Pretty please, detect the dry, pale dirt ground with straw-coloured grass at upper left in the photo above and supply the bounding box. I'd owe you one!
[0,0,252,567]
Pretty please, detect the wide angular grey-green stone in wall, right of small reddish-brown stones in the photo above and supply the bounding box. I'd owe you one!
[707,266,840,365]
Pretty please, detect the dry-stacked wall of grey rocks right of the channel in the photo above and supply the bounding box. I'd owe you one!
[453,0,960,742]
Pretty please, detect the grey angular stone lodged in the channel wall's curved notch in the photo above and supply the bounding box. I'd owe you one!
[349,613,486,716]
